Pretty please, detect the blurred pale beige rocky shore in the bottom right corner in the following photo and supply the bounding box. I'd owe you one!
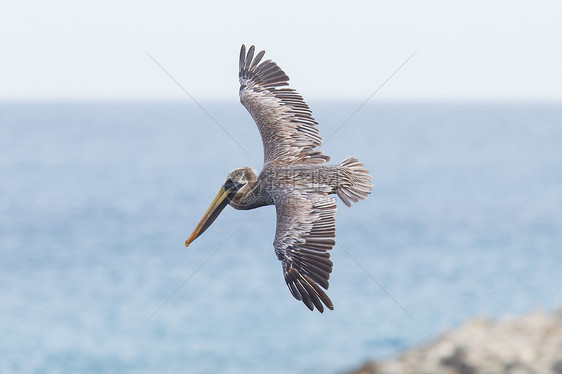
[350,309,562,374]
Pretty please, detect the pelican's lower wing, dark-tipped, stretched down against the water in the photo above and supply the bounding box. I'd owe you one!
[273,190,337,313]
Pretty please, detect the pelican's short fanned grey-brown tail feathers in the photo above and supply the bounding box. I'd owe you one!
[336,157,373,206]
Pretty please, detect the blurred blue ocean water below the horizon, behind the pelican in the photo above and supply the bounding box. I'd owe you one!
[0,102,562,373]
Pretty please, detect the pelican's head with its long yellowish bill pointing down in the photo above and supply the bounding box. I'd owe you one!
[185,167,256,247]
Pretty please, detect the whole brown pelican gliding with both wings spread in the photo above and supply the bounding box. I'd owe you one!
[185,45,372,313]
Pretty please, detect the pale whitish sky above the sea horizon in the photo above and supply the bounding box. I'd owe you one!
[0,0,562,101]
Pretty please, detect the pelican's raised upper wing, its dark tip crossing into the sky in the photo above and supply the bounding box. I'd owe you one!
[238,45,330,165]
